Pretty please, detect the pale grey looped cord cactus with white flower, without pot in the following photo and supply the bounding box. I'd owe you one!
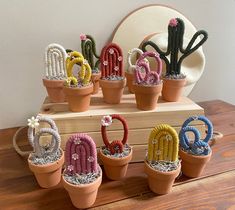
[28,116,61,157]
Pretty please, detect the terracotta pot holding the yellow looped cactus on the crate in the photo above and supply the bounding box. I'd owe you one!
[64,84,93,112]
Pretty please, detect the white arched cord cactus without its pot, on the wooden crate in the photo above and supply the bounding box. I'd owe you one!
[45,43,67,79]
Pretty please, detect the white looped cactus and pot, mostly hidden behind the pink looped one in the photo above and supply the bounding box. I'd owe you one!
[125,48,148,93]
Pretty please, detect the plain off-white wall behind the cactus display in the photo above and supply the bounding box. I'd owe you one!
[0,0,235,129]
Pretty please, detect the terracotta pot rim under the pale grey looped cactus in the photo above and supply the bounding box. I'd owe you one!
[28,148,64,173]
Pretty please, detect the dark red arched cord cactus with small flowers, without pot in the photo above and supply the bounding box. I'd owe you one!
[100,43,124,78]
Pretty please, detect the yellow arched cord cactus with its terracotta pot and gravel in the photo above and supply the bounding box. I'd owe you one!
[145,124,181,194]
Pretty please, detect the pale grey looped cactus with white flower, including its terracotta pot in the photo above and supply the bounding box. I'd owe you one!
[28,116,64,188]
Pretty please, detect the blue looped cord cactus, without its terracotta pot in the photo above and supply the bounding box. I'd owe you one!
[179,116,213,155]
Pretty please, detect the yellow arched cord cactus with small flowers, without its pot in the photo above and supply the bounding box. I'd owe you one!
[147,124,179,161]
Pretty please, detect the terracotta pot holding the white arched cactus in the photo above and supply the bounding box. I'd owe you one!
[42,79,65,103]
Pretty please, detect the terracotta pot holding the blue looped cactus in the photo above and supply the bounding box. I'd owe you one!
[179,149,212,178]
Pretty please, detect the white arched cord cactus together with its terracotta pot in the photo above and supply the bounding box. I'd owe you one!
[42,43,67,103]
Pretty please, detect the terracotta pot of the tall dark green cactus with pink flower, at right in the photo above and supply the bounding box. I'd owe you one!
[162,78,186,102]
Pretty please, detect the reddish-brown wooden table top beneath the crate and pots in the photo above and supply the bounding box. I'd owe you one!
[0,100,235,210]
